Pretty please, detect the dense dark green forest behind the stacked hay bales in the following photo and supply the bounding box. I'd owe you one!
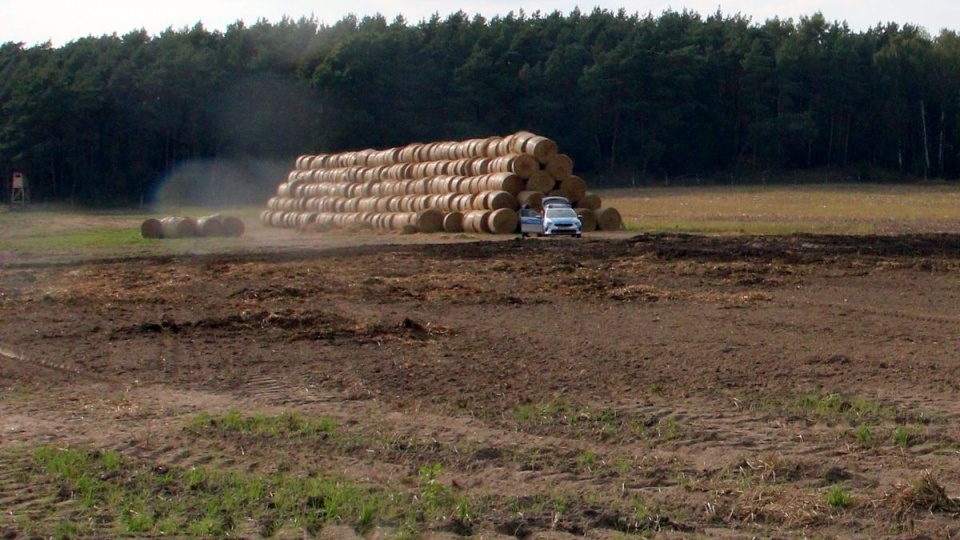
[0,10,960,206]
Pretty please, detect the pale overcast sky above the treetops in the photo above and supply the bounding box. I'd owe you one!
[0,0,960,47]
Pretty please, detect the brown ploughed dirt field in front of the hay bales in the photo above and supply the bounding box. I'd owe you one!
[0,214,960,539]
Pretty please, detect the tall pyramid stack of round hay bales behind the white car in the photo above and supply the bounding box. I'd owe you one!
[260,131,623,234]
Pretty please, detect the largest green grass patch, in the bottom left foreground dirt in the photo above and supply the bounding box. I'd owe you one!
[14,447,402,538]
